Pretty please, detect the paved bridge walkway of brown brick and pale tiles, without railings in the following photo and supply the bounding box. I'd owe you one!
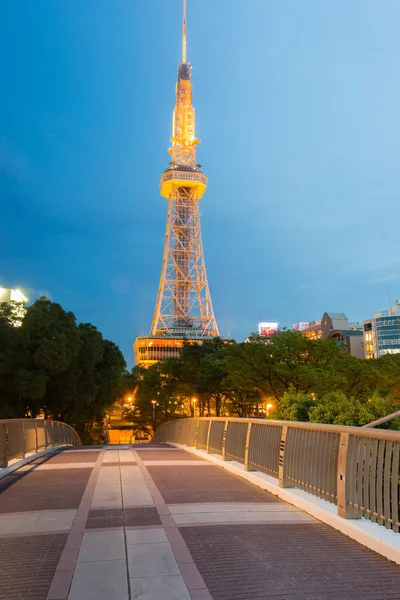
[0,445,400,600]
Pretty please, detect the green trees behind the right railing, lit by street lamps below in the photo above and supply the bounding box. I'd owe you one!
[125,331,400,433]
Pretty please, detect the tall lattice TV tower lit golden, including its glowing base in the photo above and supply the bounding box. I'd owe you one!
[134,0,219,364]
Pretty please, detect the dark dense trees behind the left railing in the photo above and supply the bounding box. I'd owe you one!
[0,297,125,441]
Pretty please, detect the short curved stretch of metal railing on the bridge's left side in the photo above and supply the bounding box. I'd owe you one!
[0,419,82,468]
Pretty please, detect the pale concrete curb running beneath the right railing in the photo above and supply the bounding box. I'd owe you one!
[173,442,400,565]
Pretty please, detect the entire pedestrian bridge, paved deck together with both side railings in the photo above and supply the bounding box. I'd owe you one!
[0,419,400,600]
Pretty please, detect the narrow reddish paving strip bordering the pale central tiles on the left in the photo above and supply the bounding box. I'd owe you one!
[46,448,105,600]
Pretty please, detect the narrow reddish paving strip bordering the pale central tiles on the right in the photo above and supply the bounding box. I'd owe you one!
[132,449,211,600]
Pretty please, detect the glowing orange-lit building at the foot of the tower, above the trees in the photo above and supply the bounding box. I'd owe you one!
[133,335,215,367]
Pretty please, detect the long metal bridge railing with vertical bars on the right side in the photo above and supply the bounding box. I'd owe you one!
[153,418,400,533]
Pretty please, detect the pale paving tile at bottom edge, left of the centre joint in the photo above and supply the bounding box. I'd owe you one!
[68,560,129,600]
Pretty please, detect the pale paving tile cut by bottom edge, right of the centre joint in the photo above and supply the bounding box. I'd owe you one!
[130,575,191,600]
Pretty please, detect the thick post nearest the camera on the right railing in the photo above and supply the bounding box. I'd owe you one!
[337,432,361,519]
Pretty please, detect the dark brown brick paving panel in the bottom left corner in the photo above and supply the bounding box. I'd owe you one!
[0,534,67,600]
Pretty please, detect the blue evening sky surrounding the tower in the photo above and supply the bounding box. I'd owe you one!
[0,0,400,366]
